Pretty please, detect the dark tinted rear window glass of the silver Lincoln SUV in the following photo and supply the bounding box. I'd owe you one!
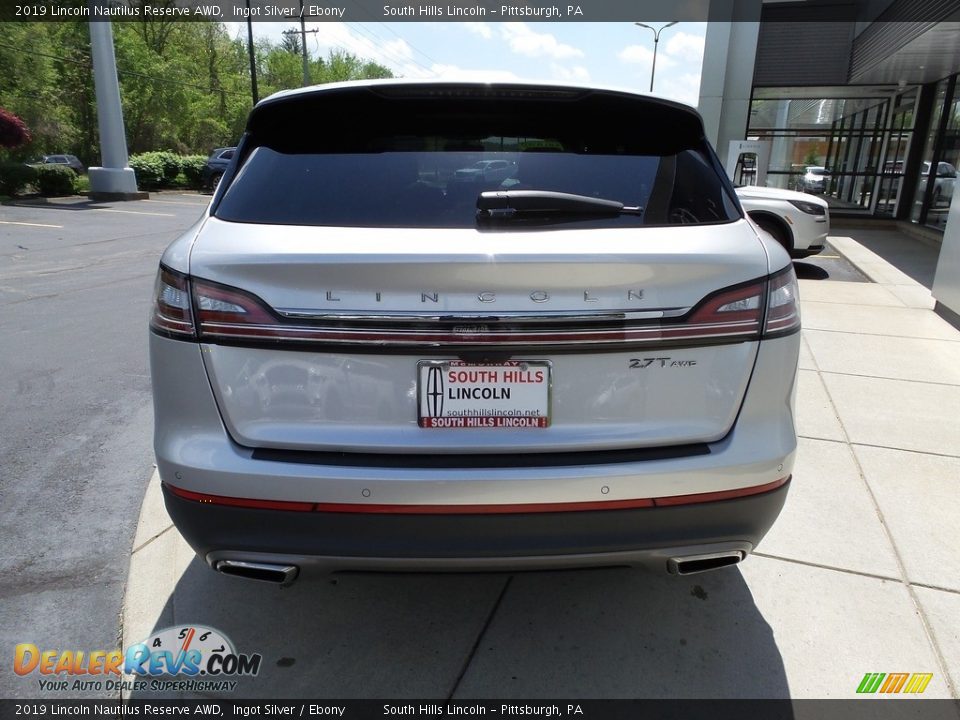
[215,91,740,229]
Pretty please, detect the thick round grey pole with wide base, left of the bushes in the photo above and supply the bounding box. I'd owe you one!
[88,22,146,200]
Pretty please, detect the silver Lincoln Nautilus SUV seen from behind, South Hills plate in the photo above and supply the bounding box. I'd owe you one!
[149,80,800,583]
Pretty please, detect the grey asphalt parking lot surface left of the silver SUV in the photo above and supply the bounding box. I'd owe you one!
[0,194,209,698]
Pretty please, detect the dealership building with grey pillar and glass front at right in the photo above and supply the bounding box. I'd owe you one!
[700,0,960,315]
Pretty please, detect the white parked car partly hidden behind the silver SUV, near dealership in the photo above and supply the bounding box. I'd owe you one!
[737,185,830,258]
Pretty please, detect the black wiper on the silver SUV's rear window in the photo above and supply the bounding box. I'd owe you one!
[477,190,643,220]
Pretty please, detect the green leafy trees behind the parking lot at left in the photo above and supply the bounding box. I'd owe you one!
[0,19,392,165]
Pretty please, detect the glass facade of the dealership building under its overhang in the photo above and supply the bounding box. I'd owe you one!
[747,75,960,230]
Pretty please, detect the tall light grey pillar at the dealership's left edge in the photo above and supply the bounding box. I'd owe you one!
[699,0,760,157]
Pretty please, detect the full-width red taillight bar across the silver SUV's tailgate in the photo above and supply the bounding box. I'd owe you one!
[150,266,800,348]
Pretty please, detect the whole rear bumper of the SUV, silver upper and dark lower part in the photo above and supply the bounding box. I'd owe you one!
[151,334,799,572]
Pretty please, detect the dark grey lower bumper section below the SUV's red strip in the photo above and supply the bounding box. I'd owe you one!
[163,483,789,573]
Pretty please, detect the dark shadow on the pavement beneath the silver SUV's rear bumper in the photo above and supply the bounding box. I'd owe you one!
[132,559,790,699]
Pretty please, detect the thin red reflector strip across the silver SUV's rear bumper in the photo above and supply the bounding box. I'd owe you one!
[164,476,790,515]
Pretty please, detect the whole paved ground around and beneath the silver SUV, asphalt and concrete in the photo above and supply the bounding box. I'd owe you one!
[0,194,960,699]
